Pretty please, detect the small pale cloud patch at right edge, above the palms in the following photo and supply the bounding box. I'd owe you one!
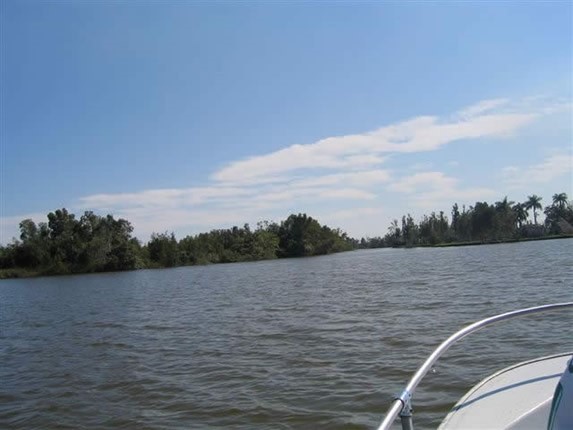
[502,154,573,189]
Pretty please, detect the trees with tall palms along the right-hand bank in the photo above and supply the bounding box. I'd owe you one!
[359,193,573,248]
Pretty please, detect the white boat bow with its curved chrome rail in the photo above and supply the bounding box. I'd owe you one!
[378,302,573,430]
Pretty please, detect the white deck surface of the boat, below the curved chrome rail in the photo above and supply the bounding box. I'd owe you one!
[439,353,572,430]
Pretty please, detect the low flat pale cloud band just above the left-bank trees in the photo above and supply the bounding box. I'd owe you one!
[62,169,390,237]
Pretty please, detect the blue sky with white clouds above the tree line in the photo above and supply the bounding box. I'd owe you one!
[0,0,573,244]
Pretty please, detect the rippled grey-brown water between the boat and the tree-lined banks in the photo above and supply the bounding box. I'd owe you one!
[0,239,573,429]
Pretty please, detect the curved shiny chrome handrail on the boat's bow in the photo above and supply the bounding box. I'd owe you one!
[378,302,573,430]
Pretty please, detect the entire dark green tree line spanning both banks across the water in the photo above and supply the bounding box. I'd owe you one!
[0,193,573,278]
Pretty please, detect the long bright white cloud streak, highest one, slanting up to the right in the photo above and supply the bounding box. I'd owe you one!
[212,99,539,185]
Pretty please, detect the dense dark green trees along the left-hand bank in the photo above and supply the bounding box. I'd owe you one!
[0,208,356,277]
